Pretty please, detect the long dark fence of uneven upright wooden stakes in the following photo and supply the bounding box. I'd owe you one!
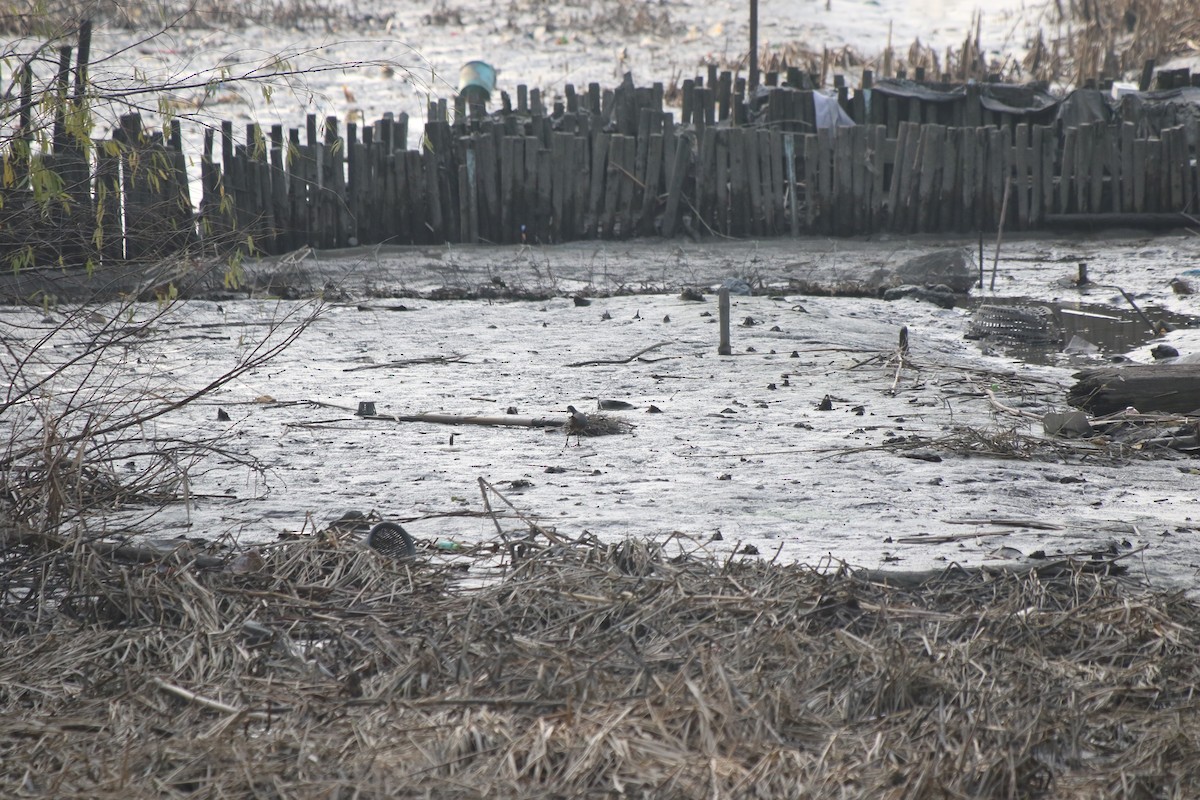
[7,65,1200,263]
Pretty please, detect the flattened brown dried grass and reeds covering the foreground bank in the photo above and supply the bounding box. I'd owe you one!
[0,527,1200,798]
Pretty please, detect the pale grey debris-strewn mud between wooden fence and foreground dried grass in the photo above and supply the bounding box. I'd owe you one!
[6,235,1200,587]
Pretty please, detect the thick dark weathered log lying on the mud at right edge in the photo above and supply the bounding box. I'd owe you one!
[1067,363,1200,415]
